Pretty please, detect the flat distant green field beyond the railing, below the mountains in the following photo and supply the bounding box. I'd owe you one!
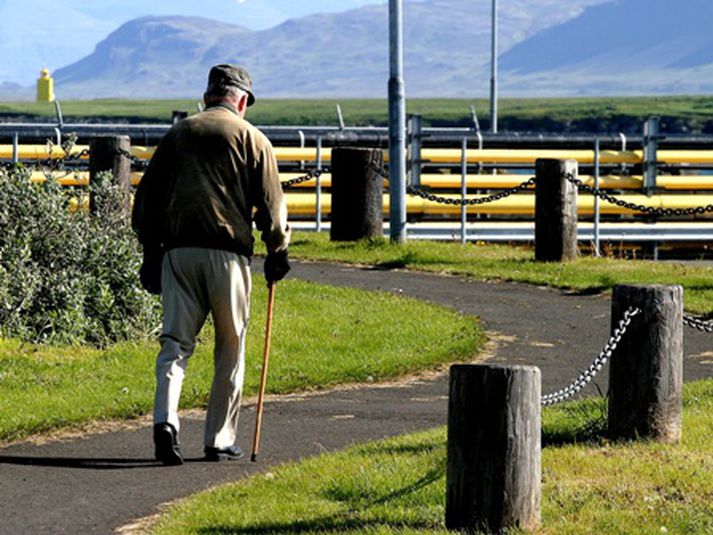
[0,95,713,131]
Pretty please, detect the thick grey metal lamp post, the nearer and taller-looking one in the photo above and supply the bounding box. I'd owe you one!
[389,0,406,243]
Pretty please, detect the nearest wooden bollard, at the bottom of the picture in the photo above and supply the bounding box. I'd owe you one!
[446,364,541,533]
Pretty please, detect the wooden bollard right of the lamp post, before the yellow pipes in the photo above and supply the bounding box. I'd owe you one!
[535,159,578,262]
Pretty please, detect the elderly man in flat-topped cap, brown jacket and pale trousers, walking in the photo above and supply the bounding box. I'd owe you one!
[132,65,290,465]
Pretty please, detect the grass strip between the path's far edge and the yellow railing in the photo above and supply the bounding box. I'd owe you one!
[280,233,713,314]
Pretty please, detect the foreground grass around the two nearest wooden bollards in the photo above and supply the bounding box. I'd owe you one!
[153,380,713,535]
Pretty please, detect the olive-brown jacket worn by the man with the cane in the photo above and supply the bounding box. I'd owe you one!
[131,105,290,257]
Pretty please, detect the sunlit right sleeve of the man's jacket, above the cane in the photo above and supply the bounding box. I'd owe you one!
[251,138,291,253]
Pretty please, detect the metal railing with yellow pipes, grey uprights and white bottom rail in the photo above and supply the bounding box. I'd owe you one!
[0,131,713,245]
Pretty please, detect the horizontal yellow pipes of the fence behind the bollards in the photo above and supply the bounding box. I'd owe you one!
[0,145,713,217]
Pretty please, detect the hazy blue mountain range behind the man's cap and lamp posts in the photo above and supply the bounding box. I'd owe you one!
[55,0,604,98]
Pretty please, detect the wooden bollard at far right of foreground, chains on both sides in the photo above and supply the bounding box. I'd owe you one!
[608,285,683,442]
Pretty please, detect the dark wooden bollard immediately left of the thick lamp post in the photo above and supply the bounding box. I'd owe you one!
[330,147,384,241]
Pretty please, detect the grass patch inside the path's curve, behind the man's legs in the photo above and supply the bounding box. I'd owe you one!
[0,278,483,440]
